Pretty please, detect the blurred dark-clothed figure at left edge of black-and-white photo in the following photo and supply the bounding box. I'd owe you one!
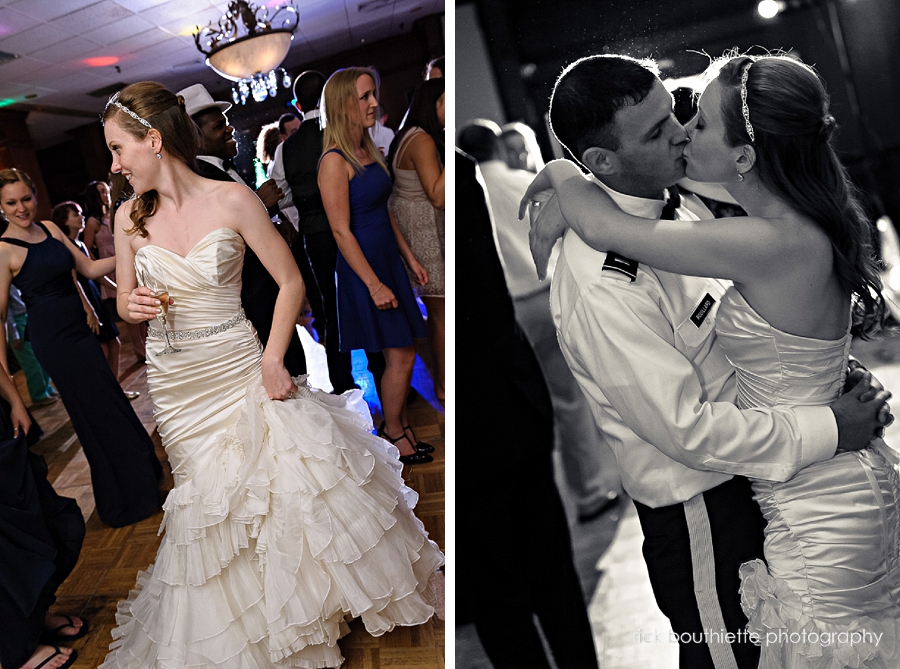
[456,153,597,669]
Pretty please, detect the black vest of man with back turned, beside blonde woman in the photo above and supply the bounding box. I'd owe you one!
[281,118,330,235]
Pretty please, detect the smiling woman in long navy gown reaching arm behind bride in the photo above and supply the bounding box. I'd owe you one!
[0,169,162,527]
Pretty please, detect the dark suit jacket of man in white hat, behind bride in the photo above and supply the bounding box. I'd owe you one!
[197,159,306,376]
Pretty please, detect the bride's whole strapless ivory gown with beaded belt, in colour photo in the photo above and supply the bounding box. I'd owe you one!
[101,228,443,669]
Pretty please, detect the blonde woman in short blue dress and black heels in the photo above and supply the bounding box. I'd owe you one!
[319,67,434,464]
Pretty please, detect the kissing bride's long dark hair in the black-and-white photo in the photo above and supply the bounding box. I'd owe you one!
[707,54,887,338]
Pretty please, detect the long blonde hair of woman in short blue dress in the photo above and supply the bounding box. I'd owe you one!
[319,67,388,172]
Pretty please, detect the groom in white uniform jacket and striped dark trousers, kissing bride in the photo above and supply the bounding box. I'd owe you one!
[544,55,884,669]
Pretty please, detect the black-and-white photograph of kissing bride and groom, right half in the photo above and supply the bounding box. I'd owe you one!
[454,0,900,669]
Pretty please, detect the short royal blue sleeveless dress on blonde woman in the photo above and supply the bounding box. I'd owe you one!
[327,149,428,351]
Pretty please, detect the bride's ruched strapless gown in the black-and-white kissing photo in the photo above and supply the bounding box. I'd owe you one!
[716,287,900,669]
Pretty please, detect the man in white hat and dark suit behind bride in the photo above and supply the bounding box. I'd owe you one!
[178,84,306,376]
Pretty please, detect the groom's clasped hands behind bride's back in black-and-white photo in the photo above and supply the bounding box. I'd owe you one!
[831,370,894,453]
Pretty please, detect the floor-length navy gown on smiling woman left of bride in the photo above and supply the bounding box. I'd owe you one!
[0,223,162,527]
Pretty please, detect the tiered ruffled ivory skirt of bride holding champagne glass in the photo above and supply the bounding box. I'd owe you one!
[101,377,443,669]
